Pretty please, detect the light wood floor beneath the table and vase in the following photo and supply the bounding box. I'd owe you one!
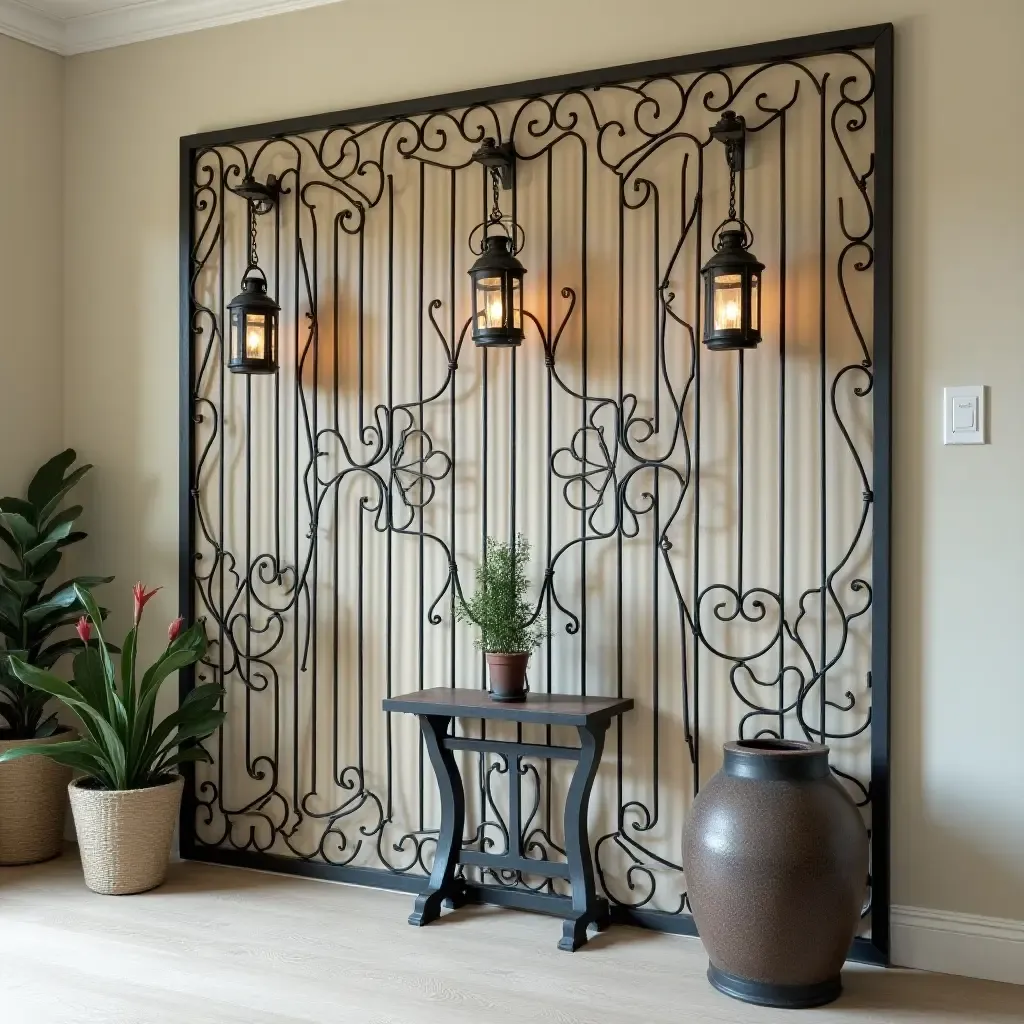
[0,855,1024,1024]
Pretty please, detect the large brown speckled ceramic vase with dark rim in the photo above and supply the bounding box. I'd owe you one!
[683,739,867,1009]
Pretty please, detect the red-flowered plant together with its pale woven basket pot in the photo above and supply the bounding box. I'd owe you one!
[0,584,224,896]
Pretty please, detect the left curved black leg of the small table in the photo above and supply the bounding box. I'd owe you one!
[409,715,466,927]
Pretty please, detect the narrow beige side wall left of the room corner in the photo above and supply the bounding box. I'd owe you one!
[0,36,65,495]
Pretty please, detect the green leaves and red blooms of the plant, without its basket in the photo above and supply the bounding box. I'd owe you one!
[0,584,224,790]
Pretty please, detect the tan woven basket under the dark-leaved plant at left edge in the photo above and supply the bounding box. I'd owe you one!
[0,729,75,864]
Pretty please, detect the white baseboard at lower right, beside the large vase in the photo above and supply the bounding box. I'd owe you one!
[891,906,1024,985]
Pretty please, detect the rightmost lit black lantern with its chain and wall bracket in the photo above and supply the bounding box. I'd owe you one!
[700,111,764,351]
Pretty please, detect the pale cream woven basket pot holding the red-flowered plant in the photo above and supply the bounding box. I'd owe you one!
[68,775,184,896]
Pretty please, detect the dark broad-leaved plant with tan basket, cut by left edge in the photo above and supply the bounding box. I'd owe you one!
[0,449,113,864]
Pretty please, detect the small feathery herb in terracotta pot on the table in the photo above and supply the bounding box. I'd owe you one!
[456,534,547,700]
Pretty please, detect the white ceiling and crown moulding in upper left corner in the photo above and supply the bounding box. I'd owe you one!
[0,0,348,56]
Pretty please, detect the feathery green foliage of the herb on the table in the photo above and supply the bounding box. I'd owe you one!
[456,534,548,654]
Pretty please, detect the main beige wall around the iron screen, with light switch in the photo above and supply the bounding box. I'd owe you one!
[58,0,1024,933]
